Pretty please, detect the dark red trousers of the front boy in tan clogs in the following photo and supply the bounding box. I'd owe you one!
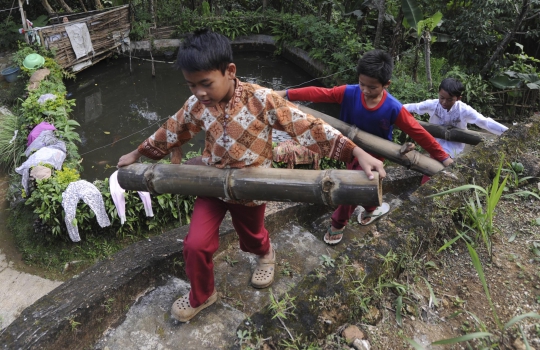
[184,197,270,308]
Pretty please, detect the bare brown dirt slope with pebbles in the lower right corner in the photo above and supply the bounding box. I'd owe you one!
[359,191,540,350]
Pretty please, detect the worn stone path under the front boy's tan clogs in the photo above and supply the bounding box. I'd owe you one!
[95,221,338,350]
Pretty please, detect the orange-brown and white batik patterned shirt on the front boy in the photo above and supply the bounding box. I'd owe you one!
[138,79,356,205]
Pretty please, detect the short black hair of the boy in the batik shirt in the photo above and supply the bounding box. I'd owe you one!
[174,29,233,74]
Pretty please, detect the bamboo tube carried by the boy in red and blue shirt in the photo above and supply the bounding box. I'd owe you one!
[298,105,444,176]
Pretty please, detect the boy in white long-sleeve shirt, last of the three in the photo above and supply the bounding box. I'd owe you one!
[403,78,508,183]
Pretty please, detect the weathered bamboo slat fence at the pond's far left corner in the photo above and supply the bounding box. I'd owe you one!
[36,5,130,70]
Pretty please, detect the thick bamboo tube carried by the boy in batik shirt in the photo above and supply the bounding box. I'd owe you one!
[118,163,382,206]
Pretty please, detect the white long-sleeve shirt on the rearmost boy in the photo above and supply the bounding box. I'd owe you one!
[403,99,508,158]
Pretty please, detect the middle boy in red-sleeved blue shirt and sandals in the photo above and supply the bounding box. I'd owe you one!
[277,50,453,245]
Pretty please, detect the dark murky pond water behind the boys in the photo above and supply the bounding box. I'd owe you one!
[66,52,339,181]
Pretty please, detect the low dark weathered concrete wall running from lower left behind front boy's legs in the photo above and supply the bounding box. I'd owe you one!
[0,203,328,349]
